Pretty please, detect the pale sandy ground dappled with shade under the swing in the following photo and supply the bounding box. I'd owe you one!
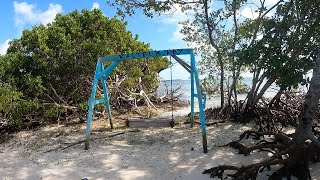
[0,105,320,180]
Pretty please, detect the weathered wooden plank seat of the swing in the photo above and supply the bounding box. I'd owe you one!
[127,118,174,128]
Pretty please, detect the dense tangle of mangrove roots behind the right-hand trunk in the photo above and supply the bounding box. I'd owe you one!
[216,92,320,132]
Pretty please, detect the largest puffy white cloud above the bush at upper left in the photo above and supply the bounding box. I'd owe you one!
[13,1,62,26]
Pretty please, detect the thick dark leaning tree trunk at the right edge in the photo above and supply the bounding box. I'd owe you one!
[272,52,320,180]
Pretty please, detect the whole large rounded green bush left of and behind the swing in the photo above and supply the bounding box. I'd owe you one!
[0,9,169,126]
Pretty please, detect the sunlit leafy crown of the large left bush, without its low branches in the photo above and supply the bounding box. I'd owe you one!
[8,9,169,104]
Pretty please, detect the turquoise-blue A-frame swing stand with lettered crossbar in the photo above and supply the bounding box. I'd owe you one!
[85,49,208,153]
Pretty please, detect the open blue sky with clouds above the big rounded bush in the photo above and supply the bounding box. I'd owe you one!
[0,0,189,79]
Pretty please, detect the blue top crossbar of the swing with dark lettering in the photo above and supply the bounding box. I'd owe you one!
[100,49,192,62]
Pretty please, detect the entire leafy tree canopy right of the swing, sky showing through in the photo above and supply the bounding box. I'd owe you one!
[109,0,320,107]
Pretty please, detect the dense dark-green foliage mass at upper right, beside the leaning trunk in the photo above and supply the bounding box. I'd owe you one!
[239,0,320,90]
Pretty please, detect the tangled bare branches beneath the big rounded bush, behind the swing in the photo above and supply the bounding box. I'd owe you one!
[0,76,180,138]
